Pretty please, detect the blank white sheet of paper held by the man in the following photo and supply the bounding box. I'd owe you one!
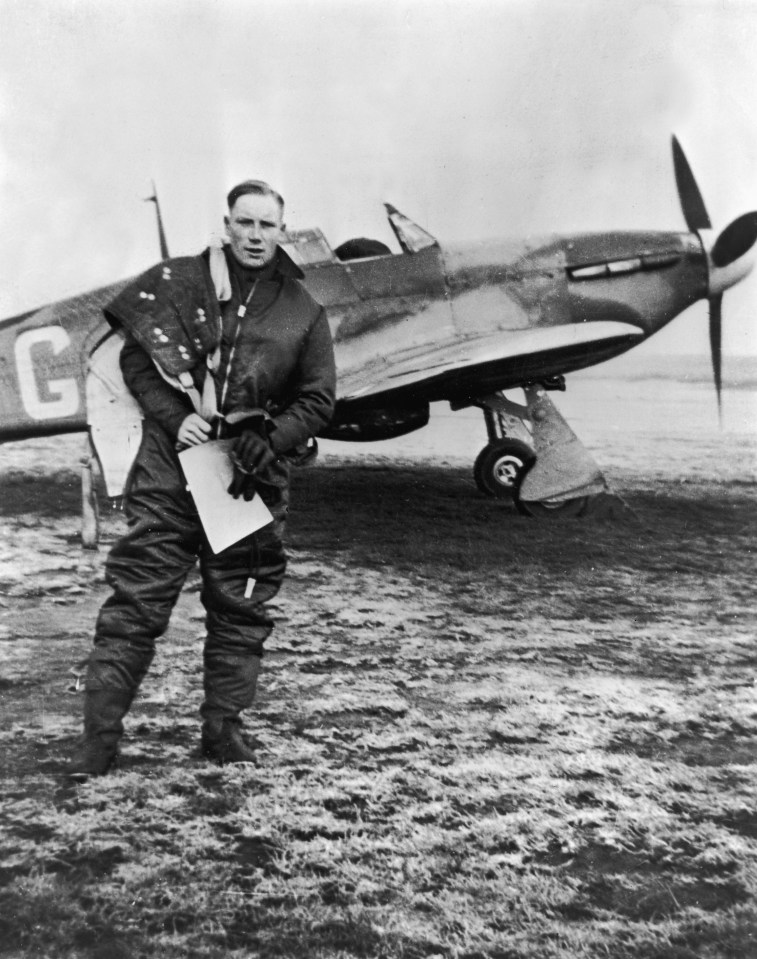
[179,440,273,553]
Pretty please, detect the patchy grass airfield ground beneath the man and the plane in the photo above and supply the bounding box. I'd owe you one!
[0,452,757,959]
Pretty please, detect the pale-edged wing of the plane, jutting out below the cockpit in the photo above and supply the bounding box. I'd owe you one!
[337,320,644,401]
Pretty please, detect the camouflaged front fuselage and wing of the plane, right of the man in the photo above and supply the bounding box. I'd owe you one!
[320,232,708,406]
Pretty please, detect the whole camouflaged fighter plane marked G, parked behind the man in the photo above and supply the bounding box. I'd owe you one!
[0,138,757,540]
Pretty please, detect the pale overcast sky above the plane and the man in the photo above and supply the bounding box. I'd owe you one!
[0,0,757,353]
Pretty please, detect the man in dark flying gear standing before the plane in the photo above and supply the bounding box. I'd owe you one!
[69,180,335,780]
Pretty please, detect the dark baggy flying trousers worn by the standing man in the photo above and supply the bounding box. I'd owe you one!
[87,421,287,696]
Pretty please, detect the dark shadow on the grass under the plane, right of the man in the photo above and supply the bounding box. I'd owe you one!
[289,464,757,572]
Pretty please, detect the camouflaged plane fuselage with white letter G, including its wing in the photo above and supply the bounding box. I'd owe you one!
[0,232,708,439]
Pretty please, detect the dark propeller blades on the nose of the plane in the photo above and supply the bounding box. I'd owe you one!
[673,137,757,423]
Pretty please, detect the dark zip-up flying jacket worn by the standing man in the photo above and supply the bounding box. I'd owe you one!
[104,248,336,454]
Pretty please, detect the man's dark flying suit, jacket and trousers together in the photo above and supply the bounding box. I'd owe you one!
[86,244,335,711]
